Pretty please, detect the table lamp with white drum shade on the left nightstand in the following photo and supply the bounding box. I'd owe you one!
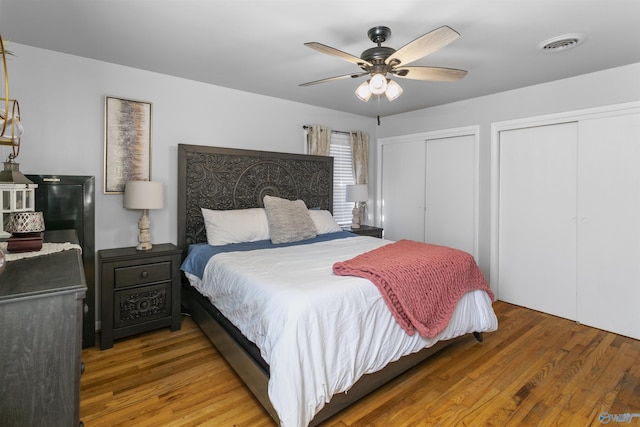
[123,181,164,251]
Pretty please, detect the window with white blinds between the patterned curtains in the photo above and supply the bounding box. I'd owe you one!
[329,132,355,225]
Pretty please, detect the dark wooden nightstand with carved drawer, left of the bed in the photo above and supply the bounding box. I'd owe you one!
[98,243,182,350]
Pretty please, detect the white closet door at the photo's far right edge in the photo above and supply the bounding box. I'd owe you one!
[578,114,640,339]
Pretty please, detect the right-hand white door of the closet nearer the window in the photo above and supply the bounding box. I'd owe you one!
[425,135,477,256]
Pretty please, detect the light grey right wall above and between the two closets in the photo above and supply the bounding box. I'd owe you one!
[371,63,640,277]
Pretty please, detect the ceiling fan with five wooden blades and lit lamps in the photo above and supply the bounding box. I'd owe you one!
[300,25,467,102]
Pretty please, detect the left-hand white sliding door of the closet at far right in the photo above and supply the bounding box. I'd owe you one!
[498,123,577,320]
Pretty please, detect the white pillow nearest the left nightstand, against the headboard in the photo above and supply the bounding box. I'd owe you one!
[202,208,269,246]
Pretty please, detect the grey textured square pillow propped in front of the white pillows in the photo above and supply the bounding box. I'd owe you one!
[263,196,318,243]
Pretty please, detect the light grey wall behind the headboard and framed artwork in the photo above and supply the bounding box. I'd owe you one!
[6,44,375,254]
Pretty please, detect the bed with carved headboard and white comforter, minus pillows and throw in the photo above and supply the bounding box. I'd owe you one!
[178,144,497,427]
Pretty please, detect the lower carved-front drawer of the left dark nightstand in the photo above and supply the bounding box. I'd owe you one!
[113,282,171,329]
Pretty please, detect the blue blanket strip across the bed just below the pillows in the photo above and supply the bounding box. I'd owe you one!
[180,231,357,279]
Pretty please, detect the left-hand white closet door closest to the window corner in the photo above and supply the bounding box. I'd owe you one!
[381,140,425,242]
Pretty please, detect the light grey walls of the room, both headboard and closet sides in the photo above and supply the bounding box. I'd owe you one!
[6,44,640,290]
